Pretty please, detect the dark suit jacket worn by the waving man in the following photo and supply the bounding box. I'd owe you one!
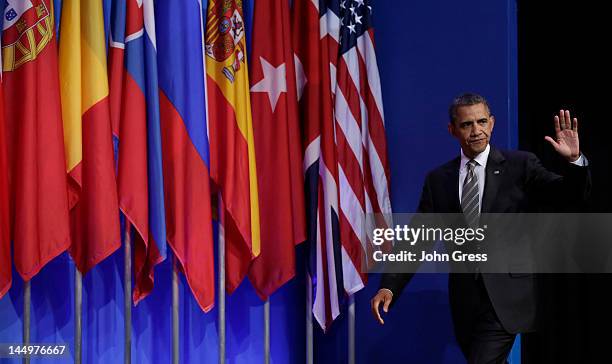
[381,147,590,333]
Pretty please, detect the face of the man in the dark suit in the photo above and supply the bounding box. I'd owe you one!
[448,104,495,158]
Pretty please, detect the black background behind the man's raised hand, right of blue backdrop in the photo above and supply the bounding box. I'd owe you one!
[518,0,612,364]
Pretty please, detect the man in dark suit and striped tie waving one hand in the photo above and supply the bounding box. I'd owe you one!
[371,94,590,364]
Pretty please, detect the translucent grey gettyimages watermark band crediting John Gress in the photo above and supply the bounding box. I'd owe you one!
[364,213,612,277]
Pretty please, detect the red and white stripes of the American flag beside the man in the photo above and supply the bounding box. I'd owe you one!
[322,7,391,294]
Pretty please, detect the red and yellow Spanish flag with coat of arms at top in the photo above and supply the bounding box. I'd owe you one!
[205,0,260,293]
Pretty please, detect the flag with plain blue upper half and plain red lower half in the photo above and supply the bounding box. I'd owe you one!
[155,0,215,311]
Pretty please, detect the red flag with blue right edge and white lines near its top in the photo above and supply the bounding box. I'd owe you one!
[109,0,166,303]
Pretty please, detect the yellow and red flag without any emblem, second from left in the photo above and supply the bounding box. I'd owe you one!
[59,0,121,273]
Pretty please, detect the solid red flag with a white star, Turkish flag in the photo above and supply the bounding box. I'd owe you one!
[249,0,306,300]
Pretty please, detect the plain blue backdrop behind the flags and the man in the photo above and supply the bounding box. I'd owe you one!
[0,0,518,364]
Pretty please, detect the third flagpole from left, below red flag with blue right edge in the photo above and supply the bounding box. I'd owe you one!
[123,219,132,364]
